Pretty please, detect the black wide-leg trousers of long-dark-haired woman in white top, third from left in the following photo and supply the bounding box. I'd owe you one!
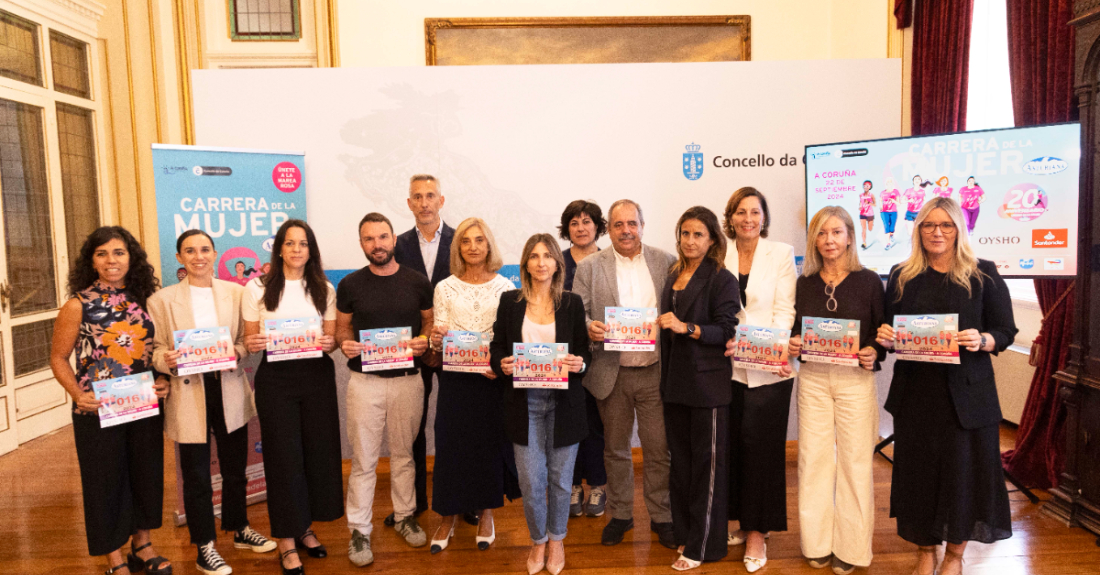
[256,355,343,539]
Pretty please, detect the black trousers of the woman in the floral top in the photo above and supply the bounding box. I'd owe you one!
[73,411,164,555]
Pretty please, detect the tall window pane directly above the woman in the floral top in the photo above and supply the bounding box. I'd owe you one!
[57,102,99,267]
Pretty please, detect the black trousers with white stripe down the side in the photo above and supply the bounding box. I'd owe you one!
[664,403,729,561]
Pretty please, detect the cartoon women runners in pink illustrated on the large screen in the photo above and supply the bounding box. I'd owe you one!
[859,174,986,250]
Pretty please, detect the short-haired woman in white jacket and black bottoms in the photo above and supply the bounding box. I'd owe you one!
[725,187,798,573]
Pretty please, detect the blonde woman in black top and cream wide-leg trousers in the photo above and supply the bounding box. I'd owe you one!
[789,206,886,575]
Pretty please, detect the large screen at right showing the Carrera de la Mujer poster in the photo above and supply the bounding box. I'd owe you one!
[805,123,1081,277]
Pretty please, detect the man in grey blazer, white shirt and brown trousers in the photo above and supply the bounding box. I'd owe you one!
[573,200,675,549]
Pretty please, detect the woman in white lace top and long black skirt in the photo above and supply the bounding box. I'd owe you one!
[431,218,519,553]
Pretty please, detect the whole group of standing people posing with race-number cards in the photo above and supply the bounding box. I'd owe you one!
[51,175,1016,575]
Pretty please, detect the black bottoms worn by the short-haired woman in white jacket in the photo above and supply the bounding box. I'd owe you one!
[729,379,794,533]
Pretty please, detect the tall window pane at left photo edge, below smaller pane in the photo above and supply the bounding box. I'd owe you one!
[0,100,57,316]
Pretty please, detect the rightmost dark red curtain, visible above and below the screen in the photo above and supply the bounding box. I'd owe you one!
[1002,0,1084,489]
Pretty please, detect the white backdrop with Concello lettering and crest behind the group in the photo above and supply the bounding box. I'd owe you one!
[193,59,901,448]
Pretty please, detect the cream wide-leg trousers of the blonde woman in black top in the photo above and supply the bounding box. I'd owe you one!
[799,363,879,566]
